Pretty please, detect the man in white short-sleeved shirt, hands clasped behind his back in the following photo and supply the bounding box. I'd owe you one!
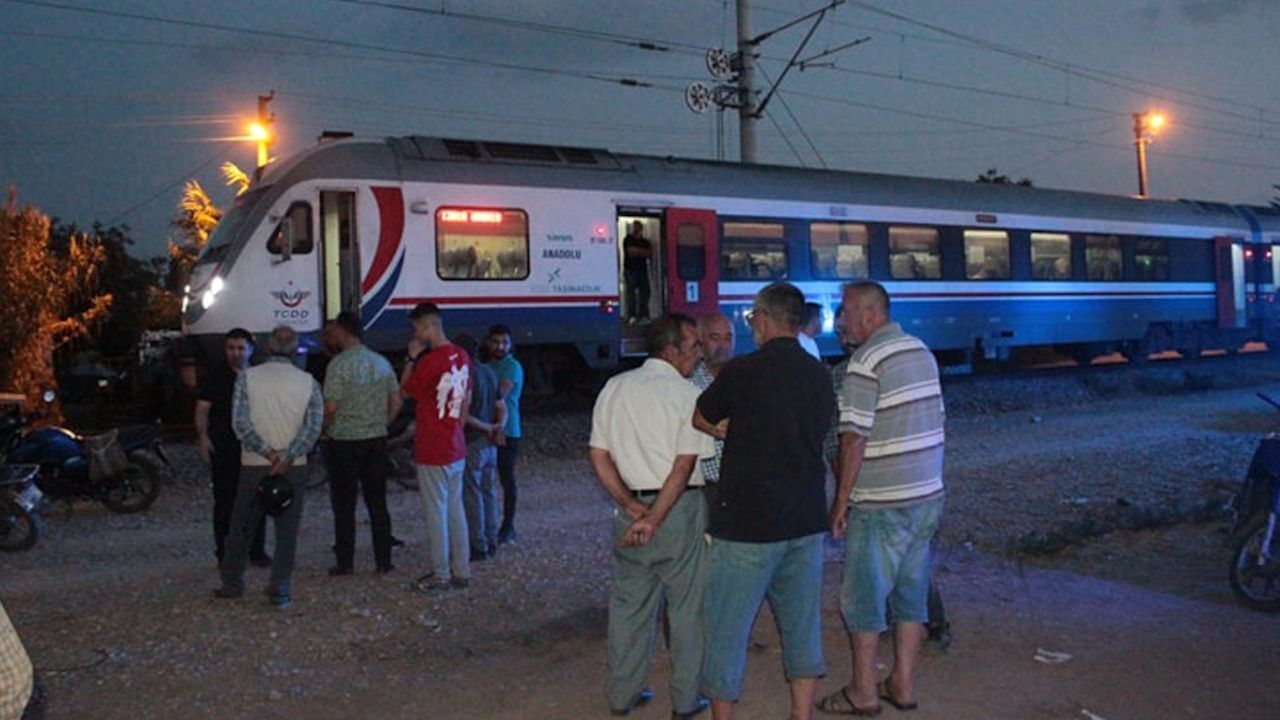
[589,315,716,717]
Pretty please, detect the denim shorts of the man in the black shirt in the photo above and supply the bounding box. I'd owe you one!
[703,533,827,702]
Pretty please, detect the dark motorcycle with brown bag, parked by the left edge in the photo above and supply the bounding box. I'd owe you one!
[0,392,170,512]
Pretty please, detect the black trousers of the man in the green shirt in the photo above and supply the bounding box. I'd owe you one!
[324,437,392,569]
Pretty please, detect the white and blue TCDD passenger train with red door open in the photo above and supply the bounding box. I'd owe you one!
[183,136,1280,369]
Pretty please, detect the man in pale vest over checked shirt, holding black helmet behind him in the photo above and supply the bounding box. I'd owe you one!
[214,325,324,610]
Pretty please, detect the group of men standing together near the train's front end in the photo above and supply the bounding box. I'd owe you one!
[196,308,524,609]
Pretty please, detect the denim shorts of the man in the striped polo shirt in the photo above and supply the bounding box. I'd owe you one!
[840,496,943,633]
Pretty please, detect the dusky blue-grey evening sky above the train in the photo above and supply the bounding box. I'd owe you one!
[0,0,1280,256]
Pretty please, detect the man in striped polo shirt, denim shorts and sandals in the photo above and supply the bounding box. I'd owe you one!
[819,281,943,715]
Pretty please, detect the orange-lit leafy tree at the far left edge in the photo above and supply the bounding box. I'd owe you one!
[0,188,111,406]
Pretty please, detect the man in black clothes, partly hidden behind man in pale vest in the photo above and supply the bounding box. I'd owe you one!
[196,328,271,568]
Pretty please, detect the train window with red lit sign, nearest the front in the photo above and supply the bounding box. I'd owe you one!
[435,208,529,281]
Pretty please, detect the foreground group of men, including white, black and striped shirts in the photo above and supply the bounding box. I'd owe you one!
[589,282,943,720]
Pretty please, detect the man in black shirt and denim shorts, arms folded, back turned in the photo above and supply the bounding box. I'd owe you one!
[694,283,836,720]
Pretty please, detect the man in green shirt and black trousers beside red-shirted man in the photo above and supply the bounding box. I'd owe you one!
[324,311,401,575]
